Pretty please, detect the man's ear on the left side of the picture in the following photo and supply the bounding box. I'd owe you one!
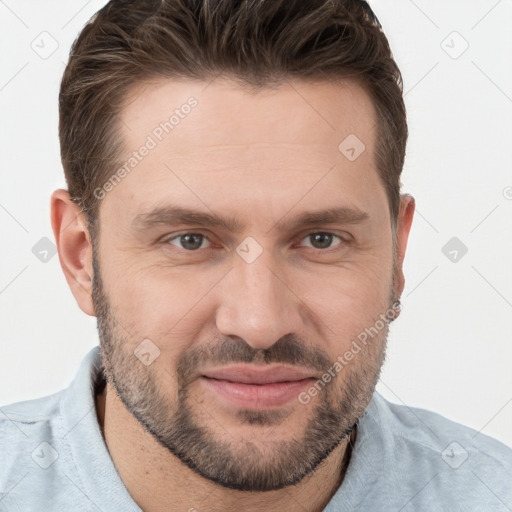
[51,189,95,316]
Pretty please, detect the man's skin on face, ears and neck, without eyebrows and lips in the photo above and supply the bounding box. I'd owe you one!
[52,79,414,512]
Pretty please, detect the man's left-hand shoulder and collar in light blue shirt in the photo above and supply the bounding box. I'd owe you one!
[0,347,139,512]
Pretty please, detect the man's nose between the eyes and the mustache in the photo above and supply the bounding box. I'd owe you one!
[216,246,306,349]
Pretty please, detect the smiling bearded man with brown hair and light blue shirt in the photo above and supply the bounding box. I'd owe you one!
[0,0,512,512]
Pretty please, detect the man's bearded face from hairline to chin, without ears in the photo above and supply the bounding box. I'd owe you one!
[93,80,404,491]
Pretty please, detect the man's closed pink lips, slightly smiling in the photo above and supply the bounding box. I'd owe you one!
[200,366,316,410]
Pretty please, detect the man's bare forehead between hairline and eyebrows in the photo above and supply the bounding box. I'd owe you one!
[100,75,382,226]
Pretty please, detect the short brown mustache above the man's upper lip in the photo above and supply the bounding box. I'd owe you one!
[176,333,331,387]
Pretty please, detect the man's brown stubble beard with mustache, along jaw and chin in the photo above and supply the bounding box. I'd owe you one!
[92,244,393,491]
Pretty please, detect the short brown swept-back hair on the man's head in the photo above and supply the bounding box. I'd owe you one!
[59,0,408,238]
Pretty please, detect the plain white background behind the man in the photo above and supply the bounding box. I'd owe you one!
[0,0,512,446]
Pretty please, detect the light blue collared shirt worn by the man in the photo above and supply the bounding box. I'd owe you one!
[0,347,512,512]
